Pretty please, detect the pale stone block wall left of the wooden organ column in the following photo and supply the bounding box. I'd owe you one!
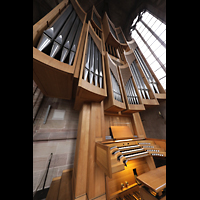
[33,96,79,191]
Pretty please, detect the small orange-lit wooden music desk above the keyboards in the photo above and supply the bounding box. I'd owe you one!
[111,126,133,139]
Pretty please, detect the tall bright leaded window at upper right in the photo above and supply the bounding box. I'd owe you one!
[131,11,166,90]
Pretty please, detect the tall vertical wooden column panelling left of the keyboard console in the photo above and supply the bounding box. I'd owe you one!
[73,102,105,199]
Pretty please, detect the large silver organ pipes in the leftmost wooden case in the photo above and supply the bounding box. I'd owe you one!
[37,4,83,65]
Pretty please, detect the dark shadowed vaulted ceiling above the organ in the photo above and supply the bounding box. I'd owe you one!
[33,0,166,40]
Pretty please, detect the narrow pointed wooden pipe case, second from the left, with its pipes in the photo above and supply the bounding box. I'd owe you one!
[74,21,107,110]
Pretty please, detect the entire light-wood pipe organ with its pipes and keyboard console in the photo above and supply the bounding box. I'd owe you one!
[33,0,166,200]
